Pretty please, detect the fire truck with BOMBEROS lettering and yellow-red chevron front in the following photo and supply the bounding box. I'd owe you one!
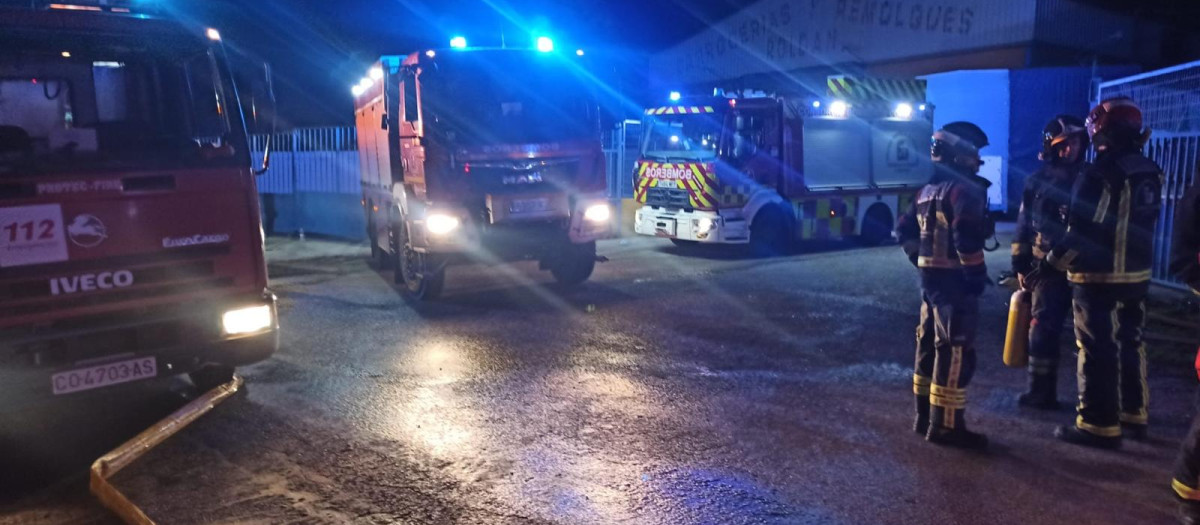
[634,83,932,255]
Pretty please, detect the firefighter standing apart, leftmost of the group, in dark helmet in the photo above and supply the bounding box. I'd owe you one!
[896,122,992,449]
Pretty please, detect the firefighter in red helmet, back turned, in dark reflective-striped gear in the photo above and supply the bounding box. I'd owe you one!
[1038,97,1162,448]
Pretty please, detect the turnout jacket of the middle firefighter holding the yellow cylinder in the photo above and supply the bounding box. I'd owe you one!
[1013,162,1090,273]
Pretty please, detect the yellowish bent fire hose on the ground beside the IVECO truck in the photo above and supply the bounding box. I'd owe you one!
[90,376,242,525]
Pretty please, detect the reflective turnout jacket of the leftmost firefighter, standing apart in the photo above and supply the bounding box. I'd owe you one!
[896,165,991,271]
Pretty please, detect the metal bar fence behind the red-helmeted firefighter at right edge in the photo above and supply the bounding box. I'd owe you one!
[1093,61,1200,288]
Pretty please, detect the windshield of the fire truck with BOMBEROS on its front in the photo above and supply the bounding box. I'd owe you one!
[642,114,721,161]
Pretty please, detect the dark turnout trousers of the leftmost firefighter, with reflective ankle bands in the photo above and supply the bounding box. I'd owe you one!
[912,270,979,429]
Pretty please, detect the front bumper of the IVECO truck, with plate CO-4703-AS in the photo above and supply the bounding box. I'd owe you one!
[0,294,278,399]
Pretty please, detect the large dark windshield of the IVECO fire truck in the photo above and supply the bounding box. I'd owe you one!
[0,37,250,176]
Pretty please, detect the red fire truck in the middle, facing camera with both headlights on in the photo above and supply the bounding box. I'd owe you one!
[354,47,612,300]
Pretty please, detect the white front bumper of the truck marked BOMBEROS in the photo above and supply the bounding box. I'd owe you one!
[634,206,750,245]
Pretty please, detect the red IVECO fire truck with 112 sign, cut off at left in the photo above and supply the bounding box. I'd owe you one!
[0,0,277,399]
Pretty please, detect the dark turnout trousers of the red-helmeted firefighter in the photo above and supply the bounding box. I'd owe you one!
[1074,283,1150,438]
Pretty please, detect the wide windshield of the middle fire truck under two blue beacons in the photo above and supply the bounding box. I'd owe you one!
[421,52,600,145]
